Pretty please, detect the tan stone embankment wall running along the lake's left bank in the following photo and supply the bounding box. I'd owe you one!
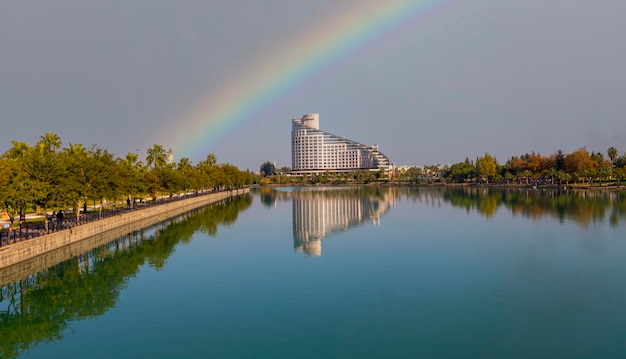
[0,188,250,276]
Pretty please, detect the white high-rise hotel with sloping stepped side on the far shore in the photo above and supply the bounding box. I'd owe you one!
[291,114,392,174]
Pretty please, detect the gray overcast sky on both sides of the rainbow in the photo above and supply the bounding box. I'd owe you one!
[0,0,626,170]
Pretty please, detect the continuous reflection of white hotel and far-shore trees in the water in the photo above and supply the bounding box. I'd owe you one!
[257,187,626,256]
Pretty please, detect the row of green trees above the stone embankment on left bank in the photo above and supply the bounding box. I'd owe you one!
[0,133,253,223]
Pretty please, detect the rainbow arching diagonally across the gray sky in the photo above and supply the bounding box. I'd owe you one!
[168,0,458,158]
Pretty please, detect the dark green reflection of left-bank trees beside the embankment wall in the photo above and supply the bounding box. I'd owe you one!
[0,195,252,358]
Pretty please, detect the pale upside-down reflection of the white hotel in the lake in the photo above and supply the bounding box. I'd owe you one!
[293,190,393,256]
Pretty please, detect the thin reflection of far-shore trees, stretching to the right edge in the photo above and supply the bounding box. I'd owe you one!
[254,187,626,227]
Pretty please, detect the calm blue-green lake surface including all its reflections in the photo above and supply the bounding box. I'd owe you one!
[0,188,626,359]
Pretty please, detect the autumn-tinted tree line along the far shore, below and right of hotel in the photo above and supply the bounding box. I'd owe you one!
[255,147,626,186]
